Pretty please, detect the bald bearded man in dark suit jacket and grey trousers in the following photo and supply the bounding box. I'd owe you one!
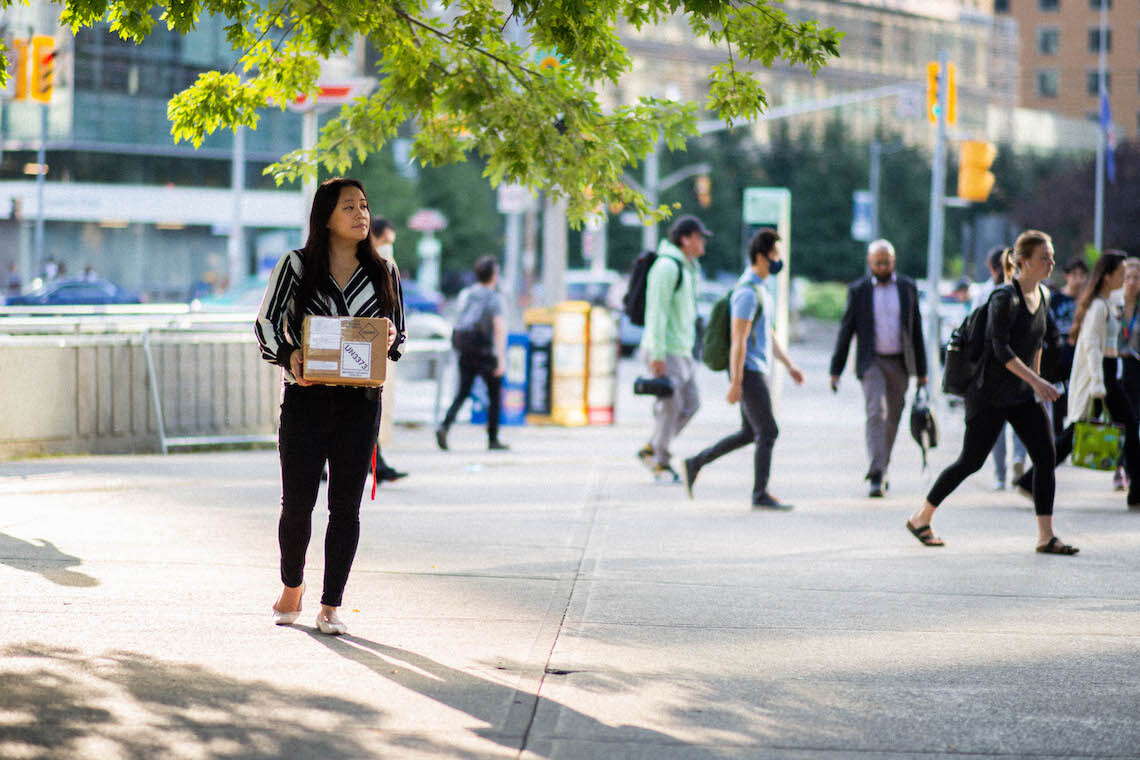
[831,240,927,497]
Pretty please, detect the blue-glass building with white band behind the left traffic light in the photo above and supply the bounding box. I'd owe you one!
[0,0,307,300]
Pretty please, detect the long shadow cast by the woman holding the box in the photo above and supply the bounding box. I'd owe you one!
[309,630,723,760]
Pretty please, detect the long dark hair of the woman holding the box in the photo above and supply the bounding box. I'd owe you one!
[293,177,396,319]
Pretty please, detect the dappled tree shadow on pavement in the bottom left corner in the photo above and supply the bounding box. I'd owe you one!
[0,643,408,760]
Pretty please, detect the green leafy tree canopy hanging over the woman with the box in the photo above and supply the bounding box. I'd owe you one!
[22,0,842,220]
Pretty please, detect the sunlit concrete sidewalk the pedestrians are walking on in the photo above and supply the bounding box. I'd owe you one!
[0,323,1140,760]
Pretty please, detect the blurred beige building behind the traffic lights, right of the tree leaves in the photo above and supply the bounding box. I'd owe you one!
[606,0,1018,151]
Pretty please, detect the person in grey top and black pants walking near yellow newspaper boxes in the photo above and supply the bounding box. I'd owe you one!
[435,256,510,451]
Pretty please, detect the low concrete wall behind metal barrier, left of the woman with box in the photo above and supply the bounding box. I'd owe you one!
[0,332,282,457]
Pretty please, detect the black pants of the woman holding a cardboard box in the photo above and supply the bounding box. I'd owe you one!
[277,385,380,607]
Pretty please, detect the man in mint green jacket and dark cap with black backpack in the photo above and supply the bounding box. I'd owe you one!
[637,215,713,483]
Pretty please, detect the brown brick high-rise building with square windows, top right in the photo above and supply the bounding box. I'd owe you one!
[994,0,1140,137]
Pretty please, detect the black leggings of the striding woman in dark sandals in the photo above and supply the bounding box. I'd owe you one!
[927,401,1057,516]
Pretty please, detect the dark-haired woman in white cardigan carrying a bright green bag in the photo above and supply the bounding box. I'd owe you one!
[1017,251,1140,509]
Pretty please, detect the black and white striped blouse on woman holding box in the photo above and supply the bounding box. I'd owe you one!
[253,251,406,383]
